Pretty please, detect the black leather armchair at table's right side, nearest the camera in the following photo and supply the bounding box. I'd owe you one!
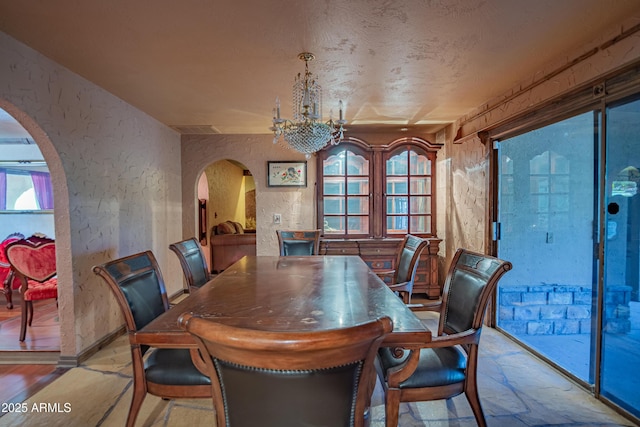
[377,249,511,427]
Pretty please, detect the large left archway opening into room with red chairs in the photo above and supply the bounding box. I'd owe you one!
[0,103,68,364]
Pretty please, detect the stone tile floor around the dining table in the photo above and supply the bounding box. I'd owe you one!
[0,312,636,427]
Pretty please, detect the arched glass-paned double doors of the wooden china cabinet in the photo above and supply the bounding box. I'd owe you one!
[318,138,439,238]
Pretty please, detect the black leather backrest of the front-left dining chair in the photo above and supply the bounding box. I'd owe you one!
[93,251,169,332]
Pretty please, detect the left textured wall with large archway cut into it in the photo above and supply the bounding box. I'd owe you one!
[0,33,185,357]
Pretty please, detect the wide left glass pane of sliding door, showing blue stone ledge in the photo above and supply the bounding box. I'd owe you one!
[496,112,598,383]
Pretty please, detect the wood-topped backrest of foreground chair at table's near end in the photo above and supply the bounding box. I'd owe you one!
[179,313,392,427]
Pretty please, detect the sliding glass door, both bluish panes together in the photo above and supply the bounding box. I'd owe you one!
[495,97,640,417]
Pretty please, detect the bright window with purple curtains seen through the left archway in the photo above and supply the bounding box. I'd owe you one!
[0,162,53,211]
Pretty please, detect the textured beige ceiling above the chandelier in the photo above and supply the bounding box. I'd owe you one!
[0,0,640,137]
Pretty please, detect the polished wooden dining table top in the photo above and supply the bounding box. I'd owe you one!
[131,256,431,347]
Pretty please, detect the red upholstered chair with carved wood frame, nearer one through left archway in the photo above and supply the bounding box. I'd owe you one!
[6,236,58,341]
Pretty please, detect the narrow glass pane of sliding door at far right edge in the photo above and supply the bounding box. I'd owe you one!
[600,96,640,416]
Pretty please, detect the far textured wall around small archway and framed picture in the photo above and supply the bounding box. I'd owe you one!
[182,135,316,255]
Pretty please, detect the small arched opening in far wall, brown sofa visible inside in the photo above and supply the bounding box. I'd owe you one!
[202,159,256,273]
